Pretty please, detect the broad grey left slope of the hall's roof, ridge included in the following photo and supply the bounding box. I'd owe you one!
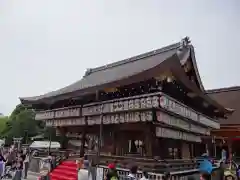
[20,40,181,102]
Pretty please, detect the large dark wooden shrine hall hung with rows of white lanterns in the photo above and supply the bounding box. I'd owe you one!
[20,38,232,167]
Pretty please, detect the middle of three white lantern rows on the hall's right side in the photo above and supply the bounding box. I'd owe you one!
[157,111,210,135]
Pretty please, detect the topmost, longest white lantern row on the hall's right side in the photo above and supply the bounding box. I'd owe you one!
[159,96,220,129]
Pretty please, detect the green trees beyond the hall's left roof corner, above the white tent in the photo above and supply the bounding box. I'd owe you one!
[0,104,59,144]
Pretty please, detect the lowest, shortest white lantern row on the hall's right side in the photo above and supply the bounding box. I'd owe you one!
[156,127,201,142]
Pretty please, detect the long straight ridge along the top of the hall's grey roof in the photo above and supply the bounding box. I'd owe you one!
[84,42,181,77]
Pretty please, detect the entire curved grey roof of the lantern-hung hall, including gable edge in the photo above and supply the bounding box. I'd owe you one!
[20,38,218,112]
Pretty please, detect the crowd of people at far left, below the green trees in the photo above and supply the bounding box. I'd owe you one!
[0,146,29,180]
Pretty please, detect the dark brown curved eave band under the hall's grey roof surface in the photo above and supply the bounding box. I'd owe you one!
[22,51,232,118]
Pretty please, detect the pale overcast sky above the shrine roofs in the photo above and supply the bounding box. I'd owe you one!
[0,0,240,115]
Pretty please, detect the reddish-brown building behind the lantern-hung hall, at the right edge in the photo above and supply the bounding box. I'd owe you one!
[207,86,240,157]
